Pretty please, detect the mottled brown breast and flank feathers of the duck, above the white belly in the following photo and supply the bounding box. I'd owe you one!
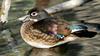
[21,21,58,45]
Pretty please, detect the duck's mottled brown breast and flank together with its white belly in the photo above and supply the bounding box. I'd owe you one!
[21,21,76,48]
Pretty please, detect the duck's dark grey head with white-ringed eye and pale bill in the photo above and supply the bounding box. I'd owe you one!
[18,8,50,22]
